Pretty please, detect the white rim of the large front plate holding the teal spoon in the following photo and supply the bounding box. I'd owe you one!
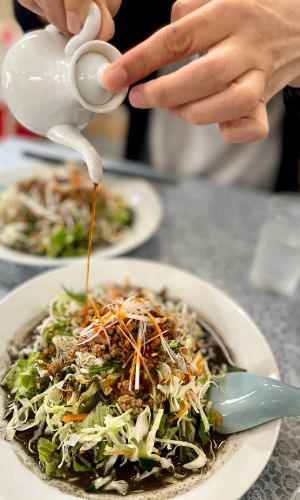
[0,259,280,500]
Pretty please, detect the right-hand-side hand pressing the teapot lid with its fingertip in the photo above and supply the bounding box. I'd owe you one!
[105,0,300,142]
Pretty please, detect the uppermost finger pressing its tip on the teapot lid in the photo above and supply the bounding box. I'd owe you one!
[105,2,232,91]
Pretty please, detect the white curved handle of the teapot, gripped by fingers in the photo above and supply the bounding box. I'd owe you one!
[65,2,102,56]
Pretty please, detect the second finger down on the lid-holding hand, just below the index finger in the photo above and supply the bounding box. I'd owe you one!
[129,40,251,108]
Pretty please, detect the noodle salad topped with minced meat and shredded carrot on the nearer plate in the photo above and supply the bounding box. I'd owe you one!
[1,284,226,495]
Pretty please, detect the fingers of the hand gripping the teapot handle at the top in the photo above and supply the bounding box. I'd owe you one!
[19,0,122,40]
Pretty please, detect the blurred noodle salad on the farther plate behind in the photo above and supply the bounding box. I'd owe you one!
[0,164,133,258]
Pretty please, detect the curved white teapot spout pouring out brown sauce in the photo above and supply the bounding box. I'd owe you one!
[47,125,103,184]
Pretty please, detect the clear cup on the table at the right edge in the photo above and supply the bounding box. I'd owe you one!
[250,194,300,295]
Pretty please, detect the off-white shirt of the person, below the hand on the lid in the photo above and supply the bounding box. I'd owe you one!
[148,59,284,189]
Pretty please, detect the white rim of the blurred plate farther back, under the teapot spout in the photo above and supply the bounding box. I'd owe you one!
[0,165,163,267]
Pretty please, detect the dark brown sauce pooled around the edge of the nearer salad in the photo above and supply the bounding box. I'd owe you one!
[8,329,228,495]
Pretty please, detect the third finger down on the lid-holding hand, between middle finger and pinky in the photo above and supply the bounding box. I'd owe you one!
[172,70,266,125]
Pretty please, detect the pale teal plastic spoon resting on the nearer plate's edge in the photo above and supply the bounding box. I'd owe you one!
[208,372,300,434]
